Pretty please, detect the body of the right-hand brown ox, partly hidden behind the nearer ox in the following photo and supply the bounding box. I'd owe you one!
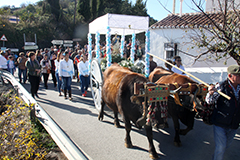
[151,72,204,146]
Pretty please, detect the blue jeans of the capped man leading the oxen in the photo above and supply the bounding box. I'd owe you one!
[213,125,237,160]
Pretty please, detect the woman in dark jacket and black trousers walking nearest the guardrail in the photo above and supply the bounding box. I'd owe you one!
[26,52,41,98]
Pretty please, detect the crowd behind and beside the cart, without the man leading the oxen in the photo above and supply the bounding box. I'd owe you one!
[0,38,184,100]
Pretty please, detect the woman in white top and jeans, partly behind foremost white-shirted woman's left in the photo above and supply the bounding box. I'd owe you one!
[54,51,64,96]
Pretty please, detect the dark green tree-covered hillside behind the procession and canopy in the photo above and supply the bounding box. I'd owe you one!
[0,0,156,51]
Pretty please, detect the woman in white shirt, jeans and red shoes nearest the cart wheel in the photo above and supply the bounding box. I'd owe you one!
[78,54,90,97]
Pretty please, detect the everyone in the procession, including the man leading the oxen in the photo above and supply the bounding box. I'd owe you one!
[0,37,240,160]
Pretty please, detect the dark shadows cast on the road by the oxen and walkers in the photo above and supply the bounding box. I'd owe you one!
[19,76,240,160]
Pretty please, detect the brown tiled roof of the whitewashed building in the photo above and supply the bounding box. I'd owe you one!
[150,12,222,29]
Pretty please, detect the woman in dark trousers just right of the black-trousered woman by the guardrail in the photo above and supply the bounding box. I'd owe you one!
[40,54,51,89]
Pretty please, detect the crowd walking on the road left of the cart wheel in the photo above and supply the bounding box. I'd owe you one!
[0,46,89,100]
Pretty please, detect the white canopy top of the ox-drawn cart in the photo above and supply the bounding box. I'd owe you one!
[89,13,149,35]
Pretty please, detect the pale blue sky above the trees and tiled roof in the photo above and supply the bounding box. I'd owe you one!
[0,0,205,21]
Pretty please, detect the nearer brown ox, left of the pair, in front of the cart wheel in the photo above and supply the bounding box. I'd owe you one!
[98,64,161,159]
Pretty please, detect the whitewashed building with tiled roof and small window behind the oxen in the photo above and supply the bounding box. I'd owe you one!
[150,13,236,83]
